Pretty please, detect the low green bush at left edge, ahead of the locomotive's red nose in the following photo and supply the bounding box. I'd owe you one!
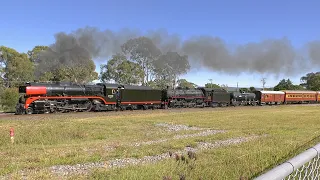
[0,88,19,112]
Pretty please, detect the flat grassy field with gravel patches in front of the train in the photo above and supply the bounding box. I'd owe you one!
[0,106,320,179]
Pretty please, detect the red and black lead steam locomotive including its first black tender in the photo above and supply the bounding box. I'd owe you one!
[16,82,163,114]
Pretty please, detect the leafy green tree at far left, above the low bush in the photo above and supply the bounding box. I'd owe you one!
[0,46,34,87]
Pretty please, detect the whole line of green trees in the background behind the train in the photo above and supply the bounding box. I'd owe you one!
[0,37,320,110]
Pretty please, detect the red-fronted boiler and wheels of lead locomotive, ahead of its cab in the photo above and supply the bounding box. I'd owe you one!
[16,82,103,114]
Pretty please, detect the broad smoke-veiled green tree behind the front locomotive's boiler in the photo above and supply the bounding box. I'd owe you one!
[28,46,98,83]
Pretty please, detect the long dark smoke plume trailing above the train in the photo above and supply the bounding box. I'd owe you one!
[38,27,320,75]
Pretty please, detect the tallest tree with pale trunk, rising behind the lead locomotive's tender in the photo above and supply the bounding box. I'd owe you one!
[121,37,161,85]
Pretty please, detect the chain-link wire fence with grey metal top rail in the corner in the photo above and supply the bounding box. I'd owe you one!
[256,143,320,180]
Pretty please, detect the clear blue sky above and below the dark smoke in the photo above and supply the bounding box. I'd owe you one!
[0,0,320,86]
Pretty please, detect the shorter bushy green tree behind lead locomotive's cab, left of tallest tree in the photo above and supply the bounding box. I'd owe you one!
[100,54,144,84]
